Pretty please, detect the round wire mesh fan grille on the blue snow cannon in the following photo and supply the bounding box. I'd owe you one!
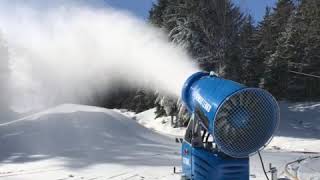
[214,88,279,158]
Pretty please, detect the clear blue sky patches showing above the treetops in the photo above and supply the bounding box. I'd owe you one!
[105,0,277,21]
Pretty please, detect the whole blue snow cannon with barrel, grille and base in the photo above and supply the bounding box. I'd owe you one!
[181,72,280,180]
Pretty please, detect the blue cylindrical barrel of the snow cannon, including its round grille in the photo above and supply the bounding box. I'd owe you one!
[182,72,280,158]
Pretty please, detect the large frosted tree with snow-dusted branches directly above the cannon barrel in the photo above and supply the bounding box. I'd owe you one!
[154,0,243,74]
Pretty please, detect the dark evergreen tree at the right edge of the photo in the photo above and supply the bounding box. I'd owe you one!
[269,0,320,100]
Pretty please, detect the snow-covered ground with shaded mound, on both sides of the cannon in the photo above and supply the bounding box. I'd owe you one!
[0,103,320,180]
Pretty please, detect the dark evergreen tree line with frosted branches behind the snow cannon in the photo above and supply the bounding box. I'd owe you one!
[101,0,320,125]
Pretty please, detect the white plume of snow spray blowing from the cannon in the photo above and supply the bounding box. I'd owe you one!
[0,3,197,112]
